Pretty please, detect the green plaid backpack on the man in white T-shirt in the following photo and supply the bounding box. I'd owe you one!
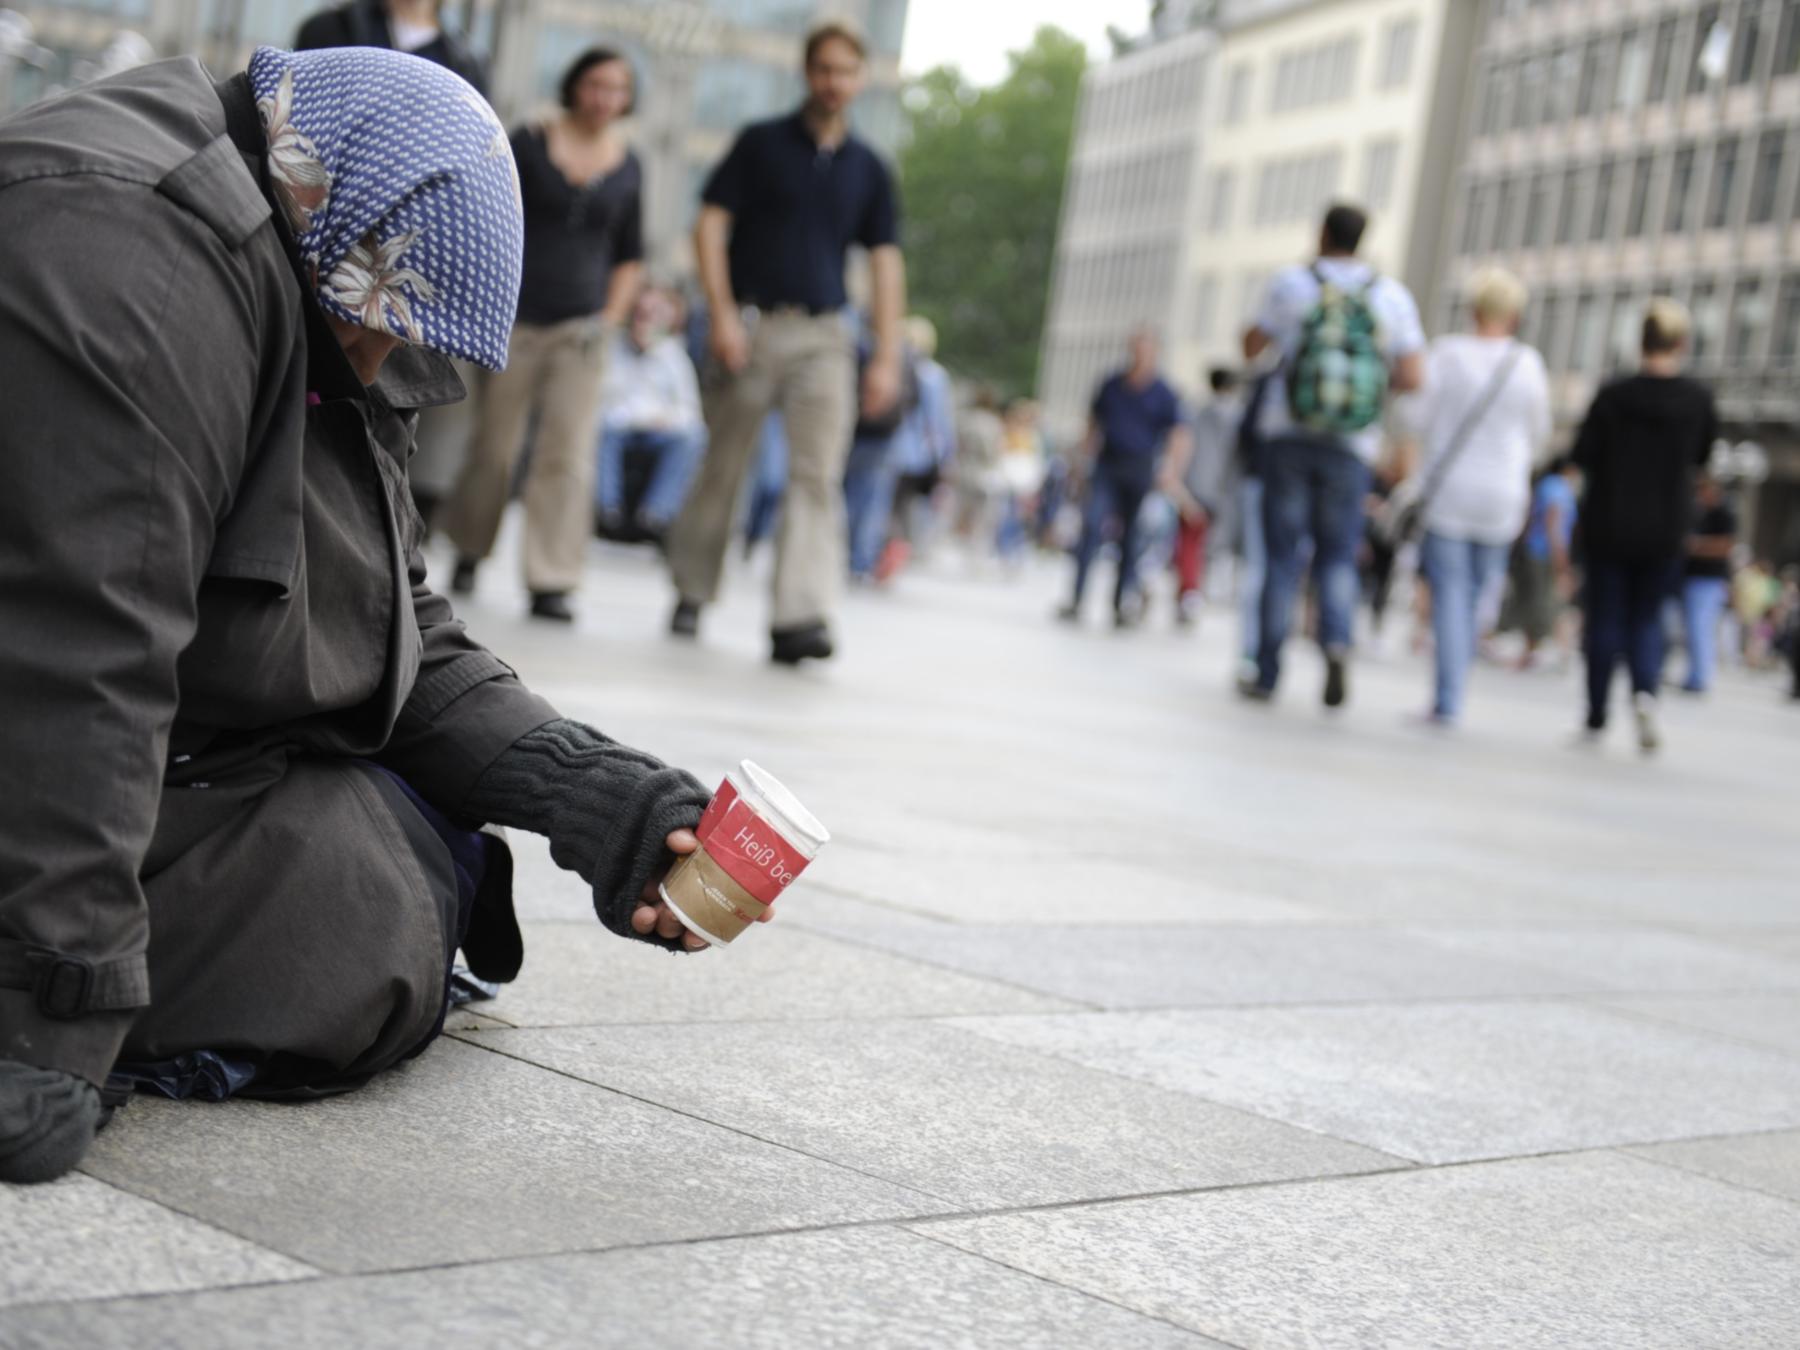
[1287,268,1388,436]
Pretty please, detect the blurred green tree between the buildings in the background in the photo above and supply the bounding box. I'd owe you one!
[900,27,1087,394]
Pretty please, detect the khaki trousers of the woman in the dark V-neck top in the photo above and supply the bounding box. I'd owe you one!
[443,317,612,594]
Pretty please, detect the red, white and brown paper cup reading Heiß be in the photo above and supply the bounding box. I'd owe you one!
[659,760,832,947]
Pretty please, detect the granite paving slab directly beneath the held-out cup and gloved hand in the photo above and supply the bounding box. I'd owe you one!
[479,920,1075,1026]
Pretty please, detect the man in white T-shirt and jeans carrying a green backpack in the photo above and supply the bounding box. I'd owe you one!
[1238,205,1426,707]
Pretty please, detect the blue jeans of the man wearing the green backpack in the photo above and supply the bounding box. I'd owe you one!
[1256,436,1368,689]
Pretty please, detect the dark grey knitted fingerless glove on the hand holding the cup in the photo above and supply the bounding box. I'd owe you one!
[463,720,713,952]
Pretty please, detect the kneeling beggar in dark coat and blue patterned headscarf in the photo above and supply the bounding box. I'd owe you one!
[0,47,709,1183]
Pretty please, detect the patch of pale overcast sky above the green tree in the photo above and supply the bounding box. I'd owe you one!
[900,0,1150,85]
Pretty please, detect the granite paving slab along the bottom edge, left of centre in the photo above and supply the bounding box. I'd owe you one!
[0,1228,1229,1350]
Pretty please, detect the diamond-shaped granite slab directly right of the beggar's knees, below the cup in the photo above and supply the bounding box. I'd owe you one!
[482,1021,1404,1206]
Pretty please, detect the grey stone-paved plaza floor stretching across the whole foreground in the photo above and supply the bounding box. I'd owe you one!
[0,551,1800,1350]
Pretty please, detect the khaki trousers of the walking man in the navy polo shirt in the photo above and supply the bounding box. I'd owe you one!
[670,311,857,628]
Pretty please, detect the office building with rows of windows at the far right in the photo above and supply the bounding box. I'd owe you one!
[1436,0,1800,560]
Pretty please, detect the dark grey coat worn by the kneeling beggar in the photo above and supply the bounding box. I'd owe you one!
[0,59,556,1082]
